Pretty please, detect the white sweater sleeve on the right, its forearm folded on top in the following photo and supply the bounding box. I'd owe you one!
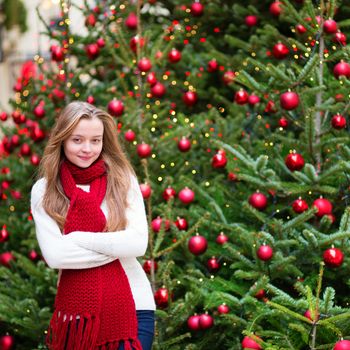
[69,176,148,258]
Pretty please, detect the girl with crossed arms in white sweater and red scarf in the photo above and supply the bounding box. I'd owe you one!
[31,102,155,350]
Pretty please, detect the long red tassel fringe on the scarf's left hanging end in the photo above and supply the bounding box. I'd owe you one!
[46,310,100,350]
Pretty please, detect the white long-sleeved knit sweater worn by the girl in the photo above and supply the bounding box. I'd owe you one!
[31,176,155,310]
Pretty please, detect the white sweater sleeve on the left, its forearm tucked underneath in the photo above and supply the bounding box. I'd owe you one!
[31,179,115,269]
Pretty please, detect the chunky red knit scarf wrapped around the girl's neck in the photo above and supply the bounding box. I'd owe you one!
[47,160,142,350]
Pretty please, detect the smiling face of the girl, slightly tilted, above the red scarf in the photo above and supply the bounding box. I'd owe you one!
[63,118,103,168]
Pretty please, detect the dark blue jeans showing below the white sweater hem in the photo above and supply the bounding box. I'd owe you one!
[119,310,154,350]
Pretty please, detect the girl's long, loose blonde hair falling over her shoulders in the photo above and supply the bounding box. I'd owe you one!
[39,101,135,231]
